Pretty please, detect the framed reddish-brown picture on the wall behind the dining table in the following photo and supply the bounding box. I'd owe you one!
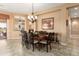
[42,17,54,30]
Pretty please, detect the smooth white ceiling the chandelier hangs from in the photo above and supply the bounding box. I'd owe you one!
[0,3,64,14]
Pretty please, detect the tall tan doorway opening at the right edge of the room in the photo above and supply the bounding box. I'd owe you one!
[68,6,79,38]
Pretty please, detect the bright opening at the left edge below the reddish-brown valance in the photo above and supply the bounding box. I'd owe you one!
[0,19,7,40]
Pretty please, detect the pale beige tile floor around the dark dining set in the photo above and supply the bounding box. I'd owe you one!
[0,39,79,56]
